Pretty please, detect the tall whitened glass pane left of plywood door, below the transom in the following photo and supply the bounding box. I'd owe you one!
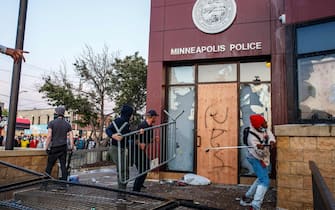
[168,86,194,171]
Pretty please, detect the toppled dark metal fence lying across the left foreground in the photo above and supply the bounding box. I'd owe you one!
[0,160,221,210]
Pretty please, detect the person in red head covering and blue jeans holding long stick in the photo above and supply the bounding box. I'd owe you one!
[240,114,276,210]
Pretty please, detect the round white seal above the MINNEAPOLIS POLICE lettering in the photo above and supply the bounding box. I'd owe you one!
[192,0,236,34]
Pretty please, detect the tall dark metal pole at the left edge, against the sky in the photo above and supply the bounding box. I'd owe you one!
[5,0,28,150]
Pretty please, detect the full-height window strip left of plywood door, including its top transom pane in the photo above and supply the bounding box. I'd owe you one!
[167,66,195,172]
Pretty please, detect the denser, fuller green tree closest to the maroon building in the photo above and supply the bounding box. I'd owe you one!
[109,52,147,123]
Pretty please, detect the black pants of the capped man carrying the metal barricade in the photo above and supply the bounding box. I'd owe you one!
[133,145,150,192]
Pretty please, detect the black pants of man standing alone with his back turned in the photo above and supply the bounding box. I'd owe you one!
[45,144,67,180]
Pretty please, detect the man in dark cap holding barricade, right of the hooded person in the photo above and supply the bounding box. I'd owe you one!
[133,109,158,192]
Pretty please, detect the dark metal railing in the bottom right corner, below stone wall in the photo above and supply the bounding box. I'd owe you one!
[309,161,335,210]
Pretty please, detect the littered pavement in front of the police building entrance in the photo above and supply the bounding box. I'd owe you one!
[72,166,277,210]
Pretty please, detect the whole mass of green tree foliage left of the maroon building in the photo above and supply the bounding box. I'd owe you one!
[39,46,147,139]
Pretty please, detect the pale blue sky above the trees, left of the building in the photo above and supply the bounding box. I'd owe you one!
[0,0,150,112]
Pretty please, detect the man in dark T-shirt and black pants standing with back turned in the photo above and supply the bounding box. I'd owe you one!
[45,106,74,181]
